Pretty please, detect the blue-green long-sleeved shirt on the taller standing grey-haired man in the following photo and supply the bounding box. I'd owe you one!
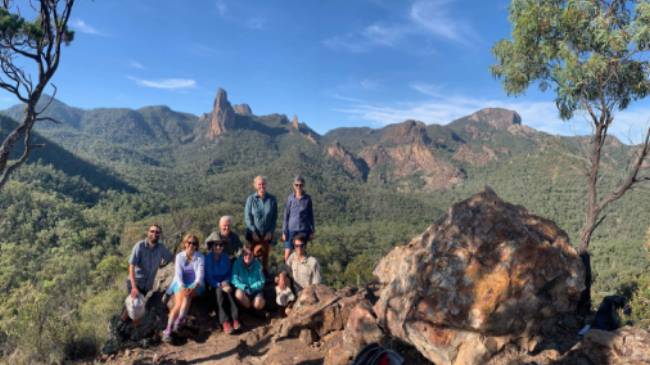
[244,193,278,235]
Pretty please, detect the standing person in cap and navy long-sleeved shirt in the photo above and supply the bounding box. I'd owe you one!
[282,175,316,262]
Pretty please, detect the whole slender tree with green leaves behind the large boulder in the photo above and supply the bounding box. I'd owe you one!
[491,0,650,312]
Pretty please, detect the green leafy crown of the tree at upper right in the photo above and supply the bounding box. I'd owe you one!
[491,0,650,119]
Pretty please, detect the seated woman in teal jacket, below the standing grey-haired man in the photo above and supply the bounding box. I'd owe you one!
[232,242,266,310]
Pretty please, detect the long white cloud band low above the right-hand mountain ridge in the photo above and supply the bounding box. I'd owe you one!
[336,83,650,143]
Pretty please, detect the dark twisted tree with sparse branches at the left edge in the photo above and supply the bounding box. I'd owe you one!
[0,0,74,189]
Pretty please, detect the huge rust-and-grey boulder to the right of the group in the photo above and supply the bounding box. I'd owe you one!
[374,188,584,365]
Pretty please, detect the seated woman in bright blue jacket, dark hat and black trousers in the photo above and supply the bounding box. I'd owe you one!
[205,239,240,334]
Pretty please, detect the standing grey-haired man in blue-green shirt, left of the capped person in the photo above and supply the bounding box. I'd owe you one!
[244,176,278,274]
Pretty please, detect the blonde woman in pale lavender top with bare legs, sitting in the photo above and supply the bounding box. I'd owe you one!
[162,234,204,341]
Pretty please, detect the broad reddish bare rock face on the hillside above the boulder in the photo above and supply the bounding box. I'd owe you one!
[359,143,464,190]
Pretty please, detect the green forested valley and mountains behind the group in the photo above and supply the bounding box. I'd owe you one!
[0,92,650,361]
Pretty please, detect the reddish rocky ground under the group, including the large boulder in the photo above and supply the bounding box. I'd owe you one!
[93,188,650,365]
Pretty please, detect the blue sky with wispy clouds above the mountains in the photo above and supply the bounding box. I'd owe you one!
[0,0,650,141]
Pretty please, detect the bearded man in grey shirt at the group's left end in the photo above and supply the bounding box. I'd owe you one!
[122,224,174,319]
